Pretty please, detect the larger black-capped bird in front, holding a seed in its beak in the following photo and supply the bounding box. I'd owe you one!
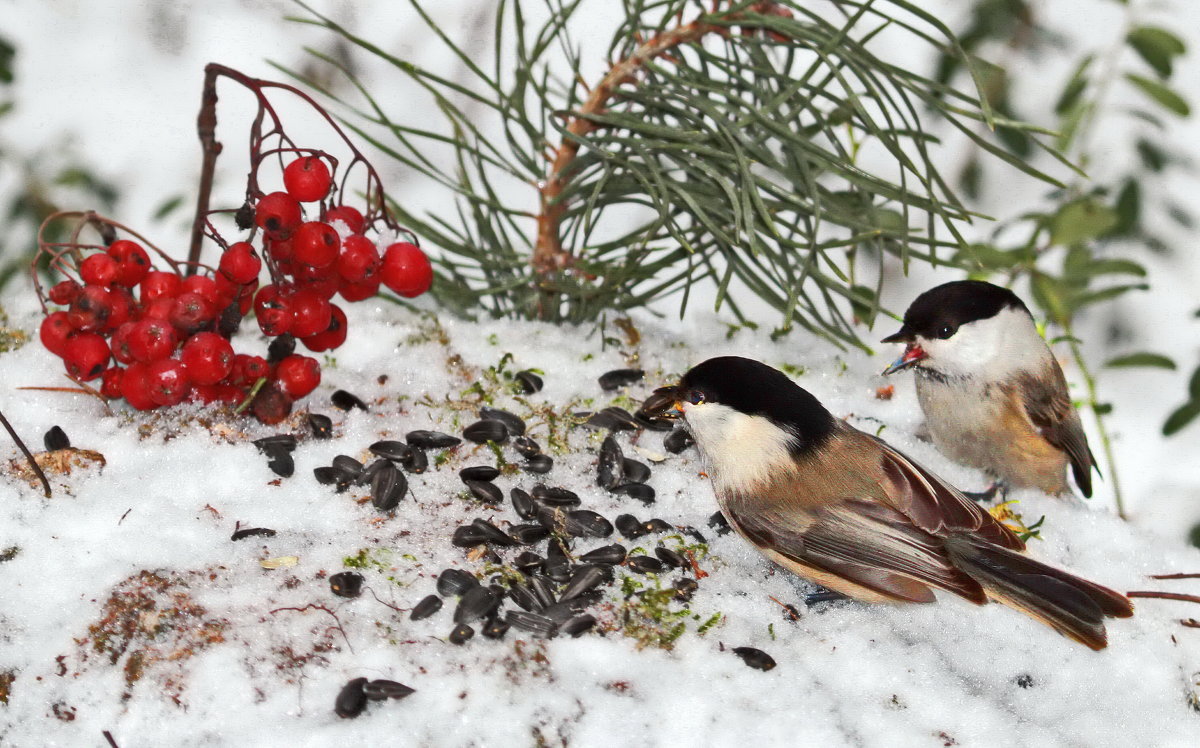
[642,357,1133,650]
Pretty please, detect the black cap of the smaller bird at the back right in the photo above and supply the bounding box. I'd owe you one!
[883,281,1030,343]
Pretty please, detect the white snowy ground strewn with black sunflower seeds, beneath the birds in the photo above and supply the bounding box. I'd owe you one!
[0,299,1200,746]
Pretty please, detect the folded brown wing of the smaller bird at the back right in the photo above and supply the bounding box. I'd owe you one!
[1015,360,1096,497]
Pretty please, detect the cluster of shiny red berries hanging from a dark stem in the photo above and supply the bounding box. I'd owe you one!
[41,156,433,423]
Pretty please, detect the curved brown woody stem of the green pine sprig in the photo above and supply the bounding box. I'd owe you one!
[530,0,791,279]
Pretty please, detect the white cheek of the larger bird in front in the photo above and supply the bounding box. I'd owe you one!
[684,403,794,493]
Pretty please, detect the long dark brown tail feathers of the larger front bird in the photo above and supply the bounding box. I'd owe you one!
[946,535,1133,650]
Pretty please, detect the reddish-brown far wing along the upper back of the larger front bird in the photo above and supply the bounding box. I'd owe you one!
[856,431,1025,551]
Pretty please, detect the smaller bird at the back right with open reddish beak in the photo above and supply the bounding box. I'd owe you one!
[883,281,1096,497]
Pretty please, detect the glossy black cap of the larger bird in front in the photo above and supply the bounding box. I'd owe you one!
[678,355,836,453]
